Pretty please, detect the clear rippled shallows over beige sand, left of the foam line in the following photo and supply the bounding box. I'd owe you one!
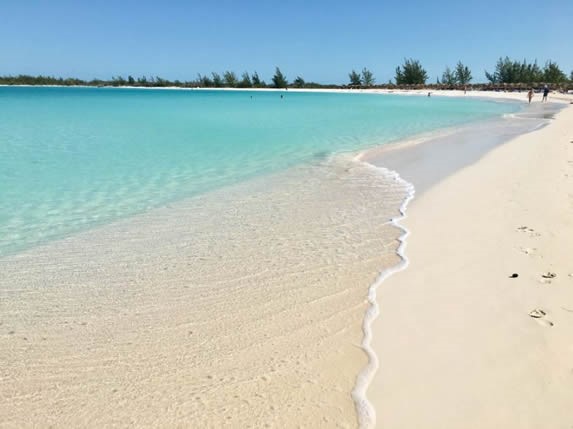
[0,157,405,428]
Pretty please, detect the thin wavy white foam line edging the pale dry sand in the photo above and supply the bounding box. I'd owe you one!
[352,161,415,429]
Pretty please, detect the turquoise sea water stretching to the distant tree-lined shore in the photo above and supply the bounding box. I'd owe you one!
[0,87,517,256]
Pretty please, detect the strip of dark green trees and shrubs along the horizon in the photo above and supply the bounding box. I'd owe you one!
[0,57,573,89]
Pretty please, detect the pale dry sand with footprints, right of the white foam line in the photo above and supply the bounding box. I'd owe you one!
[367,94,573,429]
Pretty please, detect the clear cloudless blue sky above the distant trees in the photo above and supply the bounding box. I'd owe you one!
[0,0,573,83]
